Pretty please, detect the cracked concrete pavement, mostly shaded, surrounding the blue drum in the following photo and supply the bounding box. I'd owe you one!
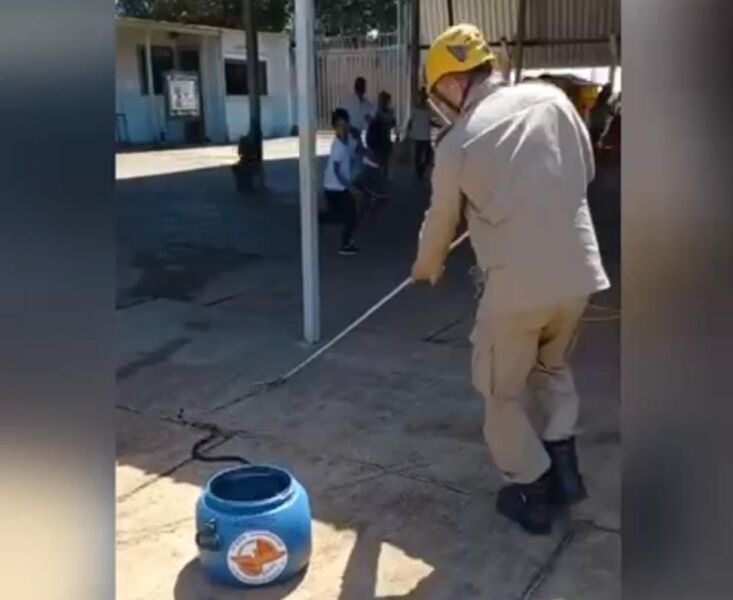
[117,141,620,600]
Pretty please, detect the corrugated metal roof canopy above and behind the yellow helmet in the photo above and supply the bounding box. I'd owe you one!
[415,0,621,69]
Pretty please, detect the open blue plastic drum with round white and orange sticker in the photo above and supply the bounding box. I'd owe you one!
[196,465,311,587]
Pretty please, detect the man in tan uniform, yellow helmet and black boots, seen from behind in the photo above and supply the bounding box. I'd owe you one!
[412,24,610,534]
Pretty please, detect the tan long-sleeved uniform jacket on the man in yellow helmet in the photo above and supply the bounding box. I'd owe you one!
[413,77,610,314]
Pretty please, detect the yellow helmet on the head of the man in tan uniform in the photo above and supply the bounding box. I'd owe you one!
[425,23,495,92]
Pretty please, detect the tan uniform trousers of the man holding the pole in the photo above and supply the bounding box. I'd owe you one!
[472,297,588,483]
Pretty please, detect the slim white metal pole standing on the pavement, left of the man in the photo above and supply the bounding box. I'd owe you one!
[295,0,321,343]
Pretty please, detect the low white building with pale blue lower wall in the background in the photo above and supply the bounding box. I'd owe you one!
[115,17,297,144]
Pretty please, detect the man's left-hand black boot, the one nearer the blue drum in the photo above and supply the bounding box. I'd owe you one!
[496,471,552,535]
